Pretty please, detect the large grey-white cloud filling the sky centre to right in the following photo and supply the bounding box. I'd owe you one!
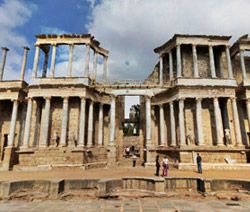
[87,0,250,79]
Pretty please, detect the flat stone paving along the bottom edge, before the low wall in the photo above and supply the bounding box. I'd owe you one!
[0,198,250,212]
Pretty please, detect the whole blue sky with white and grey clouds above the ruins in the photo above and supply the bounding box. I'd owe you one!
[0,0,250,114]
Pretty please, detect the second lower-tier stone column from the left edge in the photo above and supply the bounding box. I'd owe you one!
[22,98,33,148]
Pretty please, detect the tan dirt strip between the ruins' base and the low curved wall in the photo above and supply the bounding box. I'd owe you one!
[0,167,250,181]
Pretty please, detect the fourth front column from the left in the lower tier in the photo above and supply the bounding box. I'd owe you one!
[60,97,69,146]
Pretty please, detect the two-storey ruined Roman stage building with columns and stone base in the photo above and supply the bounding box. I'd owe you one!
[0,34,250,170]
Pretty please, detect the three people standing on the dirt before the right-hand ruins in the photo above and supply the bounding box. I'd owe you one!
[155,153,202,177]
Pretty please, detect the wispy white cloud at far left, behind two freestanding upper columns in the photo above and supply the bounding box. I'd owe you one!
[0,0,36,79]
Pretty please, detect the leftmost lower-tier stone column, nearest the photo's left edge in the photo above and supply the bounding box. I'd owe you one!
[8,99,18,147]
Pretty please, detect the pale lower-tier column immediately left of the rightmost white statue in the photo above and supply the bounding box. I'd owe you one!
[213,98,223,146]
